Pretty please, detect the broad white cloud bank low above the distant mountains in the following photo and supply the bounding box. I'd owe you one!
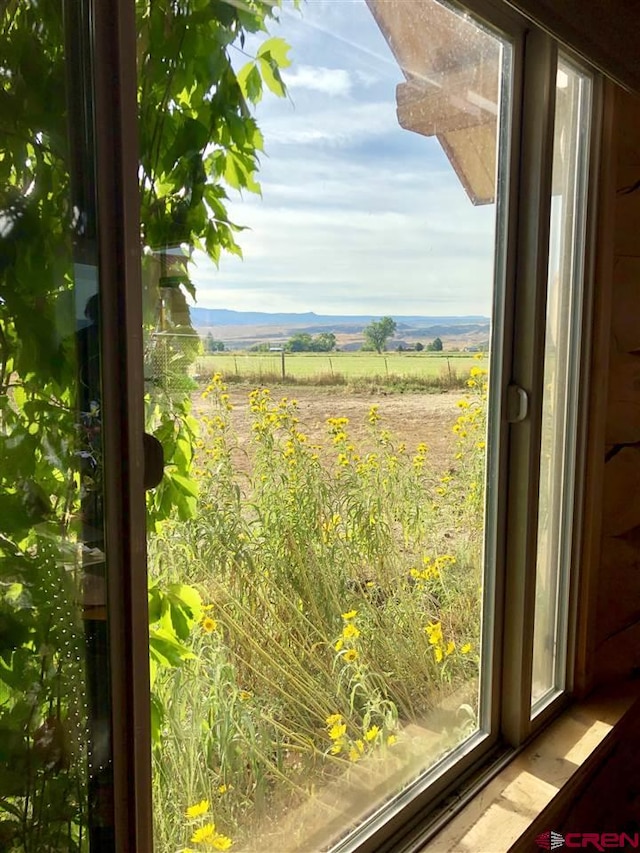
[194,184,493,314]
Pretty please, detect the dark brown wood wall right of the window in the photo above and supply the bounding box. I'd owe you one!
[594,90,640,682]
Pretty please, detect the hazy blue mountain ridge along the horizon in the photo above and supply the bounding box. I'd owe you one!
[191,308,489,331]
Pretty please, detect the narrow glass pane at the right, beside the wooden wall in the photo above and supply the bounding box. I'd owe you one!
[531,59,590,713]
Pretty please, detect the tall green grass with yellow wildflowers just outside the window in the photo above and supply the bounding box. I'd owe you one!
[150,368,484,853]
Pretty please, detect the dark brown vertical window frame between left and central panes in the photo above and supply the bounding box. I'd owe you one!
[90,0,153,853]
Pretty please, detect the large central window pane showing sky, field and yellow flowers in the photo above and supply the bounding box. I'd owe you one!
[139,0,510,853]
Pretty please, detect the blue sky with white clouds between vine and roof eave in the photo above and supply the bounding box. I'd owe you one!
[192,0,495,316]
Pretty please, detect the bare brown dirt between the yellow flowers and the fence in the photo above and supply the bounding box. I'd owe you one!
[194,386,462,470]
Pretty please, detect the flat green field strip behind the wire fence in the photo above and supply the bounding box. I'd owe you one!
[195,352,486,382]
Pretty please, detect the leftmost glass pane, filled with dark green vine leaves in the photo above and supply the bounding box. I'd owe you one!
[0,0,113,853]
